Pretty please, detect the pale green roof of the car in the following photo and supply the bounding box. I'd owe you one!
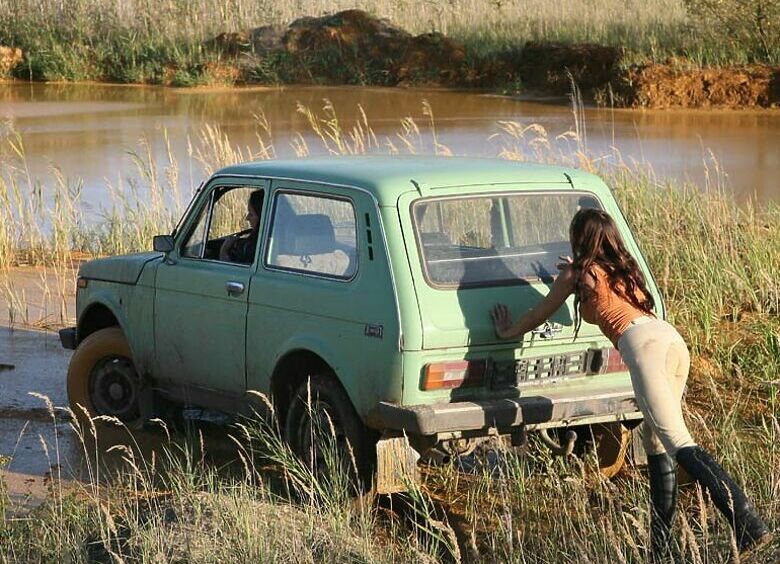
[216,156,593,205]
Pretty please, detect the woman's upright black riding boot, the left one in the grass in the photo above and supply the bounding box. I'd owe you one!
[647,452,677,561]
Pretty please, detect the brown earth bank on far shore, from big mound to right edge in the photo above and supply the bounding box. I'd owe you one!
[195,10,780,108]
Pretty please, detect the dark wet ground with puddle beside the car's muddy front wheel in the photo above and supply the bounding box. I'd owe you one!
[0,327,244,503]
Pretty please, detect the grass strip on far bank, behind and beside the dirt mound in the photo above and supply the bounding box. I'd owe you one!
[0,0,780,86]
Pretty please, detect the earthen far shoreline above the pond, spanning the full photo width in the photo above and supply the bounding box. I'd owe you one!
[0,9,780,111]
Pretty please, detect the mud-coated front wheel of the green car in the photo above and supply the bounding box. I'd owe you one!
[68,327,140,425]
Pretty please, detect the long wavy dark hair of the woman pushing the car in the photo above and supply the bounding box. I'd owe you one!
[569,208,655,334]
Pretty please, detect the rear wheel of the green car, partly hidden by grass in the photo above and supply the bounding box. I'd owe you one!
[284,375,376,491]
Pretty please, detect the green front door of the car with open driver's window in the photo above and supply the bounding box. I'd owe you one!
[154,178,267,393]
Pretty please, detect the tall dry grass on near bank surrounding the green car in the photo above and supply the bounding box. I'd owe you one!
[0,104,780,562]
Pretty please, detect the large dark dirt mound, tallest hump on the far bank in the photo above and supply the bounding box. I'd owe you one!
[204,10,466,86]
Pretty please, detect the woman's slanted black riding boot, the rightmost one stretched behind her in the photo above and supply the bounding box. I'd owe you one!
[677,446,769,552]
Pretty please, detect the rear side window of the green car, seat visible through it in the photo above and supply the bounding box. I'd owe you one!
[266,192,358,279]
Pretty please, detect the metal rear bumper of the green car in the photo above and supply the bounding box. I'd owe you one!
[378,386,642,435]
